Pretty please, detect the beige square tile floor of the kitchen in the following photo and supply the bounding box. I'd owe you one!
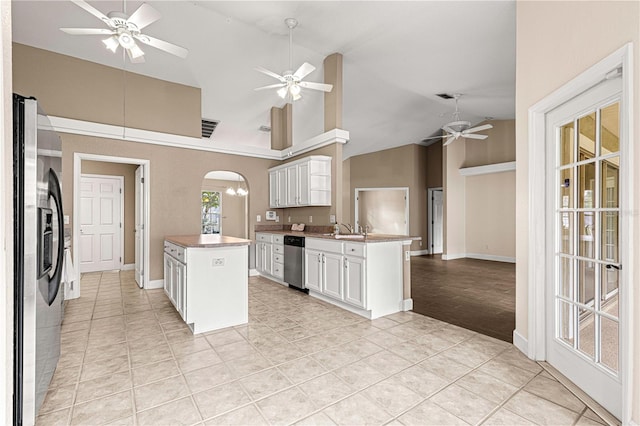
[37,272,603,426]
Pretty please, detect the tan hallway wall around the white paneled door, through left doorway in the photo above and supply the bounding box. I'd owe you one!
[81,160,138,265]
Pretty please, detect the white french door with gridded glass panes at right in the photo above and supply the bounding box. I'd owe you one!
[546,77,628,418]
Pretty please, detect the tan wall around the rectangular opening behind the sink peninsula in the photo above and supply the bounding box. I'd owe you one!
[345,145,427,250]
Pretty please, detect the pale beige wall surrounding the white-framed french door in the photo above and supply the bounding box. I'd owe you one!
[516,1,640,423]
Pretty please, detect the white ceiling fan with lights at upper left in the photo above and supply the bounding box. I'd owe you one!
[60,0,189,63]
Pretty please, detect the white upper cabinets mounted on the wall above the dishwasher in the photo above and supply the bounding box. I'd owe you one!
[269,155,331,208]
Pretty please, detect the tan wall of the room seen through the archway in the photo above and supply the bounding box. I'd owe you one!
[202,179,248,238]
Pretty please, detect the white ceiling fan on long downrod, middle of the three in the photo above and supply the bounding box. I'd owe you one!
[254,18,333,101]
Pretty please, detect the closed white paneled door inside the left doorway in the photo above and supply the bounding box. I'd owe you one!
[79,175,123,272]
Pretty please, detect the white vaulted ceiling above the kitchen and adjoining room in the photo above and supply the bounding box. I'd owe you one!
[12,0,516,158]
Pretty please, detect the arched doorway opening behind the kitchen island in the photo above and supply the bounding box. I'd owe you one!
[200,170,249,238]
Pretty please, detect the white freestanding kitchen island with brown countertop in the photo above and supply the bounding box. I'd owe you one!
[164,234,251,334]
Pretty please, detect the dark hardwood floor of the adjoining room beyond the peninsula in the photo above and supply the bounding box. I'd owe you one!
[411,255,516,342]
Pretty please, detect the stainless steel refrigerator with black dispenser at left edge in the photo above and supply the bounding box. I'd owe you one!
[13,94,64,425]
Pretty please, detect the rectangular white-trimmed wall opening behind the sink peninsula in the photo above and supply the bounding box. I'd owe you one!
[355,187,409,235]
